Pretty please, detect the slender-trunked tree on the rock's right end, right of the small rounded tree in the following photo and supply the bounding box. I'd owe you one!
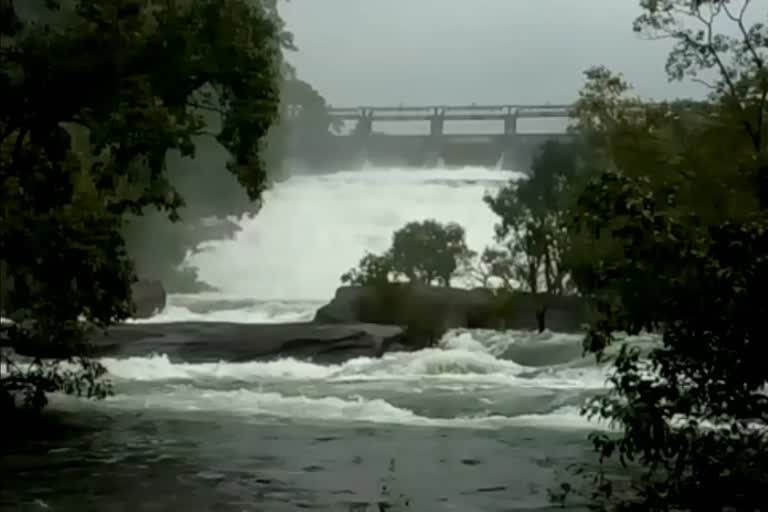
[480,141,584,294]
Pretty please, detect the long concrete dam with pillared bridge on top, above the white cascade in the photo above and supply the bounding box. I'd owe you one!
[289,104,572,170]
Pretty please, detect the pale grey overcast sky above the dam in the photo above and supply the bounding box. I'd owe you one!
[282,0,701,106]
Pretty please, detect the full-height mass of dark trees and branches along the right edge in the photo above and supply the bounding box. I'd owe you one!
[556,0,768,511]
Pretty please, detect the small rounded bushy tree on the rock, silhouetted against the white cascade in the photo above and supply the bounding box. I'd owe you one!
[341,219,474,286]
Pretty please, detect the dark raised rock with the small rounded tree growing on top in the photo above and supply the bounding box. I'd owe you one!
[315,284,590,336]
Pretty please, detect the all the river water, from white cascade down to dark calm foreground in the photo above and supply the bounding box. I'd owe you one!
[0,169,628,512]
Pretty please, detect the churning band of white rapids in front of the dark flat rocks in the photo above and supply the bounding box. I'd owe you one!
[55,330,632,429]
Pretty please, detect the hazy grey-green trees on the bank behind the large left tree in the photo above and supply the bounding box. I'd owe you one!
[123,9,335,293]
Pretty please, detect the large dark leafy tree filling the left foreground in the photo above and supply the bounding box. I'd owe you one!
[0,0,280,407]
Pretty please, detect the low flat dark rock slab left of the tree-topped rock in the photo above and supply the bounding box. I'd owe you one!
[91,322,403,363]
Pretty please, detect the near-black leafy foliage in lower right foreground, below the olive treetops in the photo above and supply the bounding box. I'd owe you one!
[564,172,768,510]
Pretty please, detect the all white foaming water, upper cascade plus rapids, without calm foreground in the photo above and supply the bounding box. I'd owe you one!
[62,168,624,429]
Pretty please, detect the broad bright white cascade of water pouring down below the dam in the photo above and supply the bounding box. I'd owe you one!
[186,167,522,301]
